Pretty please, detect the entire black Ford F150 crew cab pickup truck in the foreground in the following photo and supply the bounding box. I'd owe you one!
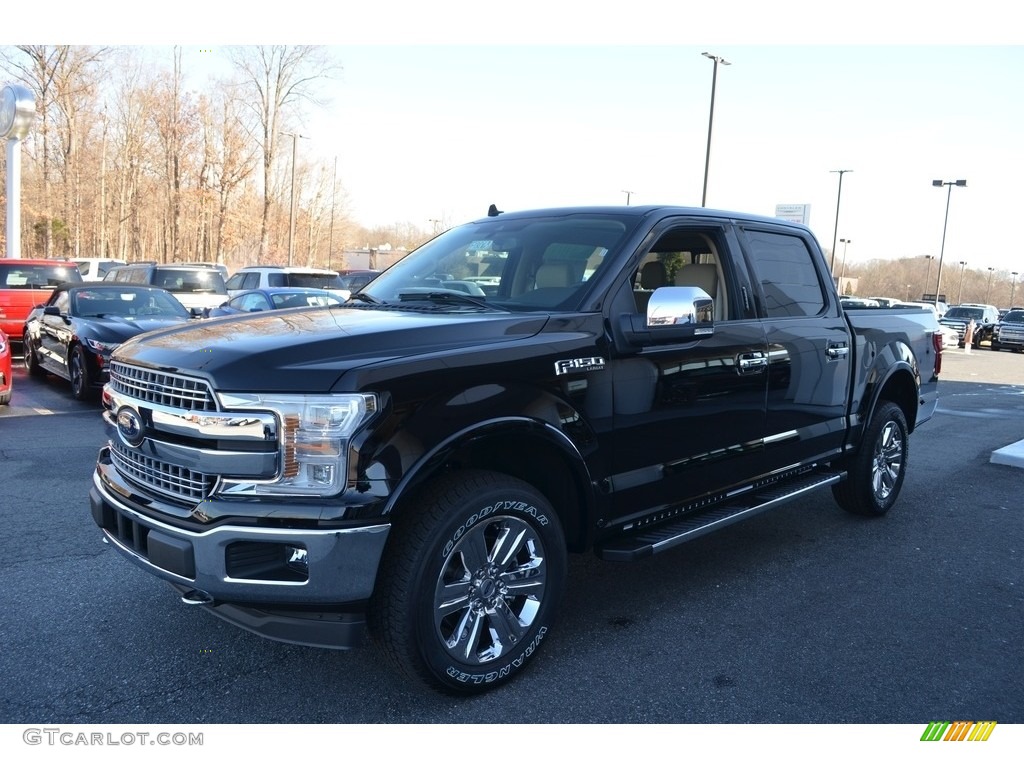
[90,206,941,693]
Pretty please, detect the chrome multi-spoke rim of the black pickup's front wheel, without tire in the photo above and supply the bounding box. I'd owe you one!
[434,516,547,665]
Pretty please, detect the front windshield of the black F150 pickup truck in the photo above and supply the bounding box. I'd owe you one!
[355,213,636,310]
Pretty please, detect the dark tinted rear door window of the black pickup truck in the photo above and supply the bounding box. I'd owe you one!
[746,230,825,317]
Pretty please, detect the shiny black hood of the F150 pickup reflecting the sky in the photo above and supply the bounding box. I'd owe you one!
[114,307,548,392]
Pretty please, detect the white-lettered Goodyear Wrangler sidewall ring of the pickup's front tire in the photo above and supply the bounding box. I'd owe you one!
[403,478,566,693]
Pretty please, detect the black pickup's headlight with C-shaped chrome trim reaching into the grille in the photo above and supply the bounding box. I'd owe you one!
[221,394,377,496]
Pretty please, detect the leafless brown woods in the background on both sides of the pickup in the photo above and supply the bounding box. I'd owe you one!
[0,45,1024,307]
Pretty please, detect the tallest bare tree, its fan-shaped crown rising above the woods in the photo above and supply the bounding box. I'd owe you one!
[229,45,338,261]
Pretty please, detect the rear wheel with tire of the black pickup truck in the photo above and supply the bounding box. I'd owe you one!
[833,400,909,517]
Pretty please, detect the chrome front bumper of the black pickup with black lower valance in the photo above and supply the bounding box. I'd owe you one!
[89,449,390,648]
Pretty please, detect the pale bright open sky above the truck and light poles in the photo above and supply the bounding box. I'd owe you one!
[8,0,1024,273]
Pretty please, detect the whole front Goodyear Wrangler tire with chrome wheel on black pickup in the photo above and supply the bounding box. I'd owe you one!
[370,471,567,694]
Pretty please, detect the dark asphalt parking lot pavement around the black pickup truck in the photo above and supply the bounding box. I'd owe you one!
[0,348,1024,733]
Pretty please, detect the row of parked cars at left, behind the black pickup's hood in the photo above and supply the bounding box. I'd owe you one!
[0,258,391,406]
